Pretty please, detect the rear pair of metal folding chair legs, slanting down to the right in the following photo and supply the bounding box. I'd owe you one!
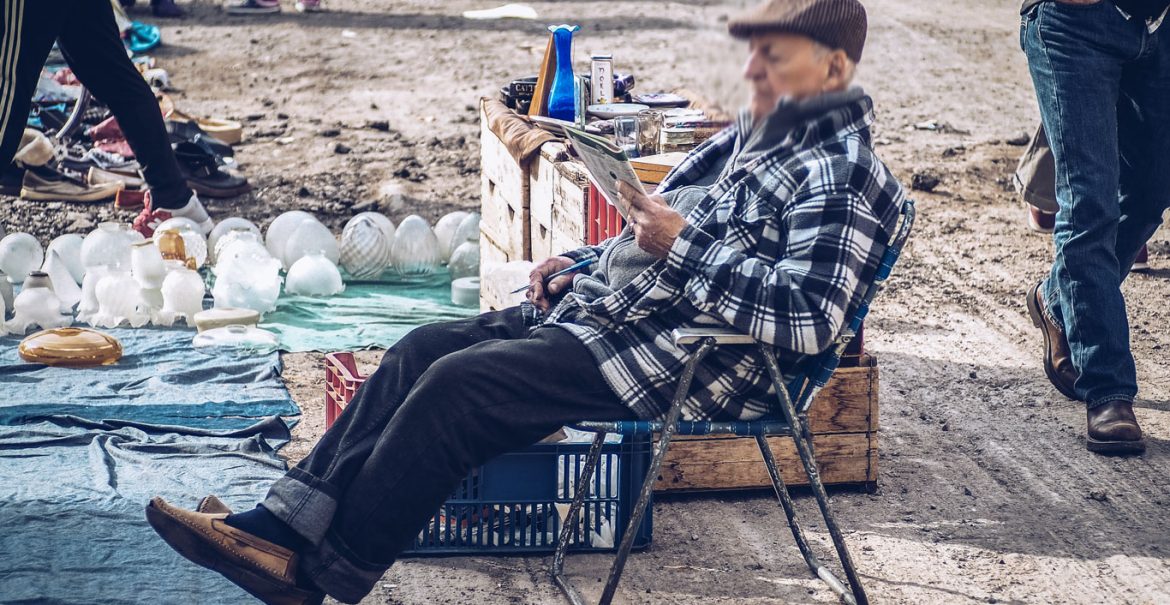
[757,345,869,605]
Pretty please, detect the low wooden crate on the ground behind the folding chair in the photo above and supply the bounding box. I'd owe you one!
[654,356,879,491]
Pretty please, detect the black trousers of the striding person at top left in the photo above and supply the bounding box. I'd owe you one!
[0,0,192,208]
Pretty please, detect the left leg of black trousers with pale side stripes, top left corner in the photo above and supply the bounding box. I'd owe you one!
[0,0,62,166]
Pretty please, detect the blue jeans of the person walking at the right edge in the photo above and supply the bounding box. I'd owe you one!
[1020,0,1170,408]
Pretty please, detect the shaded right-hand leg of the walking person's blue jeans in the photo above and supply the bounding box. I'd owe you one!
[1117,28,1170,273]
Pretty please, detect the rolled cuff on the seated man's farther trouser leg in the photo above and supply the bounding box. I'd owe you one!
[261,468,337,544]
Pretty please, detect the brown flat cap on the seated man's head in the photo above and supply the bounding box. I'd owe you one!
[728,0,868,62]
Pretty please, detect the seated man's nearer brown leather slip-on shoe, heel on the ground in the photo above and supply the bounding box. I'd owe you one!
[146,496,325,605]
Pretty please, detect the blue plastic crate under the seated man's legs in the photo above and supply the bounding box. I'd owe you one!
[405,432,653,556]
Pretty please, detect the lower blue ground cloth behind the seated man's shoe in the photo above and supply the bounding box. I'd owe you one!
[0,417,289,605]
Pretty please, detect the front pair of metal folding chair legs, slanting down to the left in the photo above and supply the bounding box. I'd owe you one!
[552,338,715,605]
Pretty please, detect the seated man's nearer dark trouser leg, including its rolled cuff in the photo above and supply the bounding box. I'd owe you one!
[292,326,635,603]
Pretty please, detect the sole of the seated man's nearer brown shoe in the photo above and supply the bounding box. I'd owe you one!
[146,502,324,605]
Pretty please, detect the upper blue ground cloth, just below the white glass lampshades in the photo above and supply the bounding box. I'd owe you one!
[0,329,301,428]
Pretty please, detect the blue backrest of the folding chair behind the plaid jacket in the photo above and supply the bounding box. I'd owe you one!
[787,199,915,414]
